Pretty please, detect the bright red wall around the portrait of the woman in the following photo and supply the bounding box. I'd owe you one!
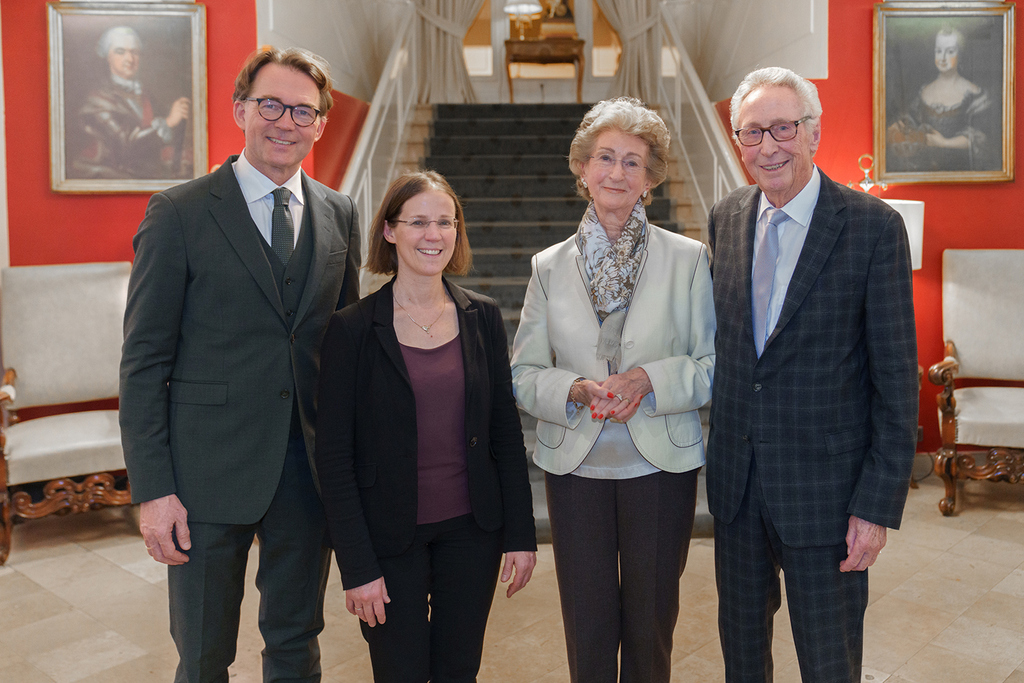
[816,0,1024,452]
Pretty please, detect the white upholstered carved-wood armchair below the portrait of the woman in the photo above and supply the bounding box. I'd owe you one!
[928,249,1024,515]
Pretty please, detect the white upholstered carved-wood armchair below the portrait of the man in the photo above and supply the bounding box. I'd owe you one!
[0,263,131,564]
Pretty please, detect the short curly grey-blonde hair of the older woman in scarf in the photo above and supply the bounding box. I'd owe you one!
[569,97,672,204]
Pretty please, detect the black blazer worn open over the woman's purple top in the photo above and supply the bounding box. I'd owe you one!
[315,281,537,589]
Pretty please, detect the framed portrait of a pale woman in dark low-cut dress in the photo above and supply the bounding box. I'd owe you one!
[874,0,1015,183]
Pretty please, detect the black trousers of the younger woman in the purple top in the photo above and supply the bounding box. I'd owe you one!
[359,515,502,683]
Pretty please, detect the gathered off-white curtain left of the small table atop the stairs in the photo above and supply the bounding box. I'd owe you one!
[415,0,483,103]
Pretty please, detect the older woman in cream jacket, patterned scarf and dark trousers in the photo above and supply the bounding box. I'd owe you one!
[512,97,715,683]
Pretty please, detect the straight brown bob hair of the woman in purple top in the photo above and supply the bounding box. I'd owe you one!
[365,171,473,275]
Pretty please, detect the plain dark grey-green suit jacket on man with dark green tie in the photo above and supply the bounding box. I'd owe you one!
[121,157,359,524]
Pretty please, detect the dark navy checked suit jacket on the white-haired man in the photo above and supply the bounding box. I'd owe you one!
[707,173,918,547]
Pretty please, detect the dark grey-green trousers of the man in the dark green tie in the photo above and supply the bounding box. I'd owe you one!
[167,435,331,683]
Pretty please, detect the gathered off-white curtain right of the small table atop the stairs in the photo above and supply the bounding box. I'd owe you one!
[595,0,662,106]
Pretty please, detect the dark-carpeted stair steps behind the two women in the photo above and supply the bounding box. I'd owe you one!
[411,104,696,541]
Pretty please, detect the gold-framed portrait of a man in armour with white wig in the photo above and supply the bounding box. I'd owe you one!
[47,2,207,193]
